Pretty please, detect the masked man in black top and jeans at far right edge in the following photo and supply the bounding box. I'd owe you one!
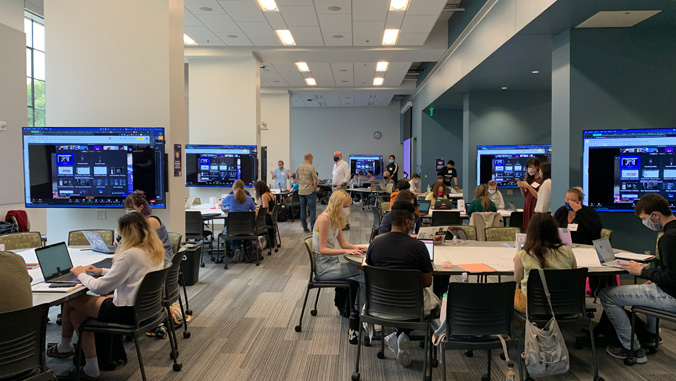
[600,193,676,364]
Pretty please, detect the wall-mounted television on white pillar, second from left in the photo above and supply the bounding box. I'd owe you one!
[185,144,258,187]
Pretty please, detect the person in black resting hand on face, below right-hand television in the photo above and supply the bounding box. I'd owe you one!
[554,188,603,245]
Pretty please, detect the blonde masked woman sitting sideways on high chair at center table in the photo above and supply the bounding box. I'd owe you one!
[312,190,366,345]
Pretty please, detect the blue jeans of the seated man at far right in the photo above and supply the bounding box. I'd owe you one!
[600,283,676,350]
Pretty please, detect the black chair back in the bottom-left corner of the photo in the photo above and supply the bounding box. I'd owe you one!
[0,304,56,380]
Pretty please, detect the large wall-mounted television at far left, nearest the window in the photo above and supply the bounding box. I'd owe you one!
[22,127,166,208]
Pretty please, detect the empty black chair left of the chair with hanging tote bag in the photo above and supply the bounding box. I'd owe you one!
[439,282,523,380]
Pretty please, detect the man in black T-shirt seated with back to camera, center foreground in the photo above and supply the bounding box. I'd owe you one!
[366,201,439,366]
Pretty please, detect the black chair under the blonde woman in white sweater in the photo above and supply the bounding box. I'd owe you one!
[75,268,174,381]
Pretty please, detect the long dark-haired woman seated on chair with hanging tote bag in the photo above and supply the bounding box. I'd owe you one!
[514,213,577,312]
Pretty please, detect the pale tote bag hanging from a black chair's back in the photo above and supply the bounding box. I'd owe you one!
[521,269,570,377]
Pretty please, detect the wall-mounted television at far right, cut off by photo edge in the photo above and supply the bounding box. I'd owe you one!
[582,128,676,212]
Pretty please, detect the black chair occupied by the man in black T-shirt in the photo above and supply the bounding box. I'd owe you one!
[352,266,432,381]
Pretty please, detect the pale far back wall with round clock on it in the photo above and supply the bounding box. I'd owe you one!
[291,104,404,179]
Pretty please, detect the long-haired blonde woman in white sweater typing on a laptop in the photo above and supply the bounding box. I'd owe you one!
[47,213,164,380]
